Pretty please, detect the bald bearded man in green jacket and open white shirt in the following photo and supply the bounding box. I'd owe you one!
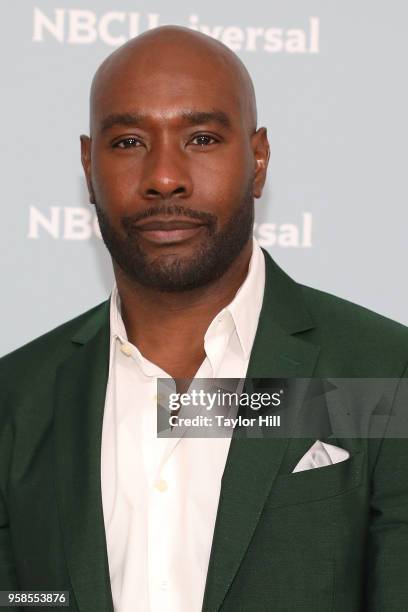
[0,26,408,612]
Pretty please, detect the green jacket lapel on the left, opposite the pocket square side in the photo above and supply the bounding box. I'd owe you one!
[54,302,113,612]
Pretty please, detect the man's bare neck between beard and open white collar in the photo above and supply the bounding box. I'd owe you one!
[114,240,252,376]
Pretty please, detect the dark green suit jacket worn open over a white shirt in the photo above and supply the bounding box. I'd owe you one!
[0,255,408,612]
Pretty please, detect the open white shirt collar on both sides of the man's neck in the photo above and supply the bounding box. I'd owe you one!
[110,238,265,358]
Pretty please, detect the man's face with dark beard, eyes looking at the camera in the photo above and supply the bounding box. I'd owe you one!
[82,46,267,291]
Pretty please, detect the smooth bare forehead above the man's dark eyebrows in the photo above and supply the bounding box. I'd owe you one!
[91,56,243,124]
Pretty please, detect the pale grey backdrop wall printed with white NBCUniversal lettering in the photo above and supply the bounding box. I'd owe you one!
[0,0,408,354]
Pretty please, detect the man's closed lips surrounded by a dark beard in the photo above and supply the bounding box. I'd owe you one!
[135,217,205,244]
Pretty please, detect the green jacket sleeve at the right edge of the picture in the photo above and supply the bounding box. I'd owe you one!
[364,370,408,612]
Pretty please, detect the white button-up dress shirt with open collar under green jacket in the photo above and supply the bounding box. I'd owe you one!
[101,239,265,612]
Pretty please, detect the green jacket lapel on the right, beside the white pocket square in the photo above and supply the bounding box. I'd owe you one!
[203,252,319,612]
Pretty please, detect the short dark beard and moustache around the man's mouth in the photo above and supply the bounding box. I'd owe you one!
[95,186,254,292]
